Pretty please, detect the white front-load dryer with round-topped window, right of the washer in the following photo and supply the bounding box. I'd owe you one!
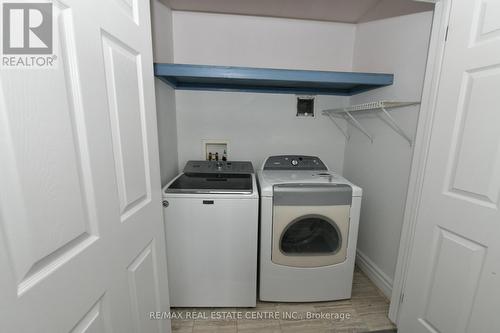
[258,155,362,302]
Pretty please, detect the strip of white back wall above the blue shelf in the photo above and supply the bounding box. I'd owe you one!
[173,11,356,71]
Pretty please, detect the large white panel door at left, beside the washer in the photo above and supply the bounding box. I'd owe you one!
[0,0,170,333]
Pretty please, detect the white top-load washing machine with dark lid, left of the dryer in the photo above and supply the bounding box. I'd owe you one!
[163,161,259,307]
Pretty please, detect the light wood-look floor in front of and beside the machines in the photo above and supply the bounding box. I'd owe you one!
[171,268,395,333]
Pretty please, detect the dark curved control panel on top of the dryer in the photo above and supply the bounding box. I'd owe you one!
[264,155,328,171]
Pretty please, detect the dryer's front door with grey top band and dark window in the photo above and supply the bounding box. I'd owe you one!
[271,186,352,267]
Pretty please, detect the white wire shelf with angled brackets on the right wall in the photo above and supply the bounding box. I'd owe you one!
[323,101,420,146]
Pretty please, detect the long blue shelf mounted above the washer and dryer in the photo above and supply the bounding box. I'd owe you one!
[154,64,394,96]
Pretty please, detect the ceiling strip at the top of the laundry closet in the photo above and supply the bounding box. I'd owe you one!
[160,0,434,23]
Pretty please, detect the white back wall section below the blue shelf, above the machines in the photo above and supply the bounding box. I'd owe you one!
[176,91,346,172]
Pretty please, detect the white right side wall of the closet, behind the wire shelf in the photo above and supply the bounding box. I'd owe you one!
[344,12,432,290]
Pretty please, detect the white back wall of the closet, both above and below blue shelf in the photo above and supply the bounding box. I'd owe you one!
[173,11,355,172]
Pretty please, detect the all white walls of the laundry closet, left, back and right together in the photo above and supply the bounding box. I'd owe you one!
[152,0,433,326]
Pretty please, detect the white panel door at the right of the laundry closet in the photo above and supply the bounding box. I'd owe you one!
[398,0,500,333]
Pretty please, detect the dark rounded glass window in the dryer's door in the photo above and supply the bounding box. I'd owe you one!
[280,215,342,256]
